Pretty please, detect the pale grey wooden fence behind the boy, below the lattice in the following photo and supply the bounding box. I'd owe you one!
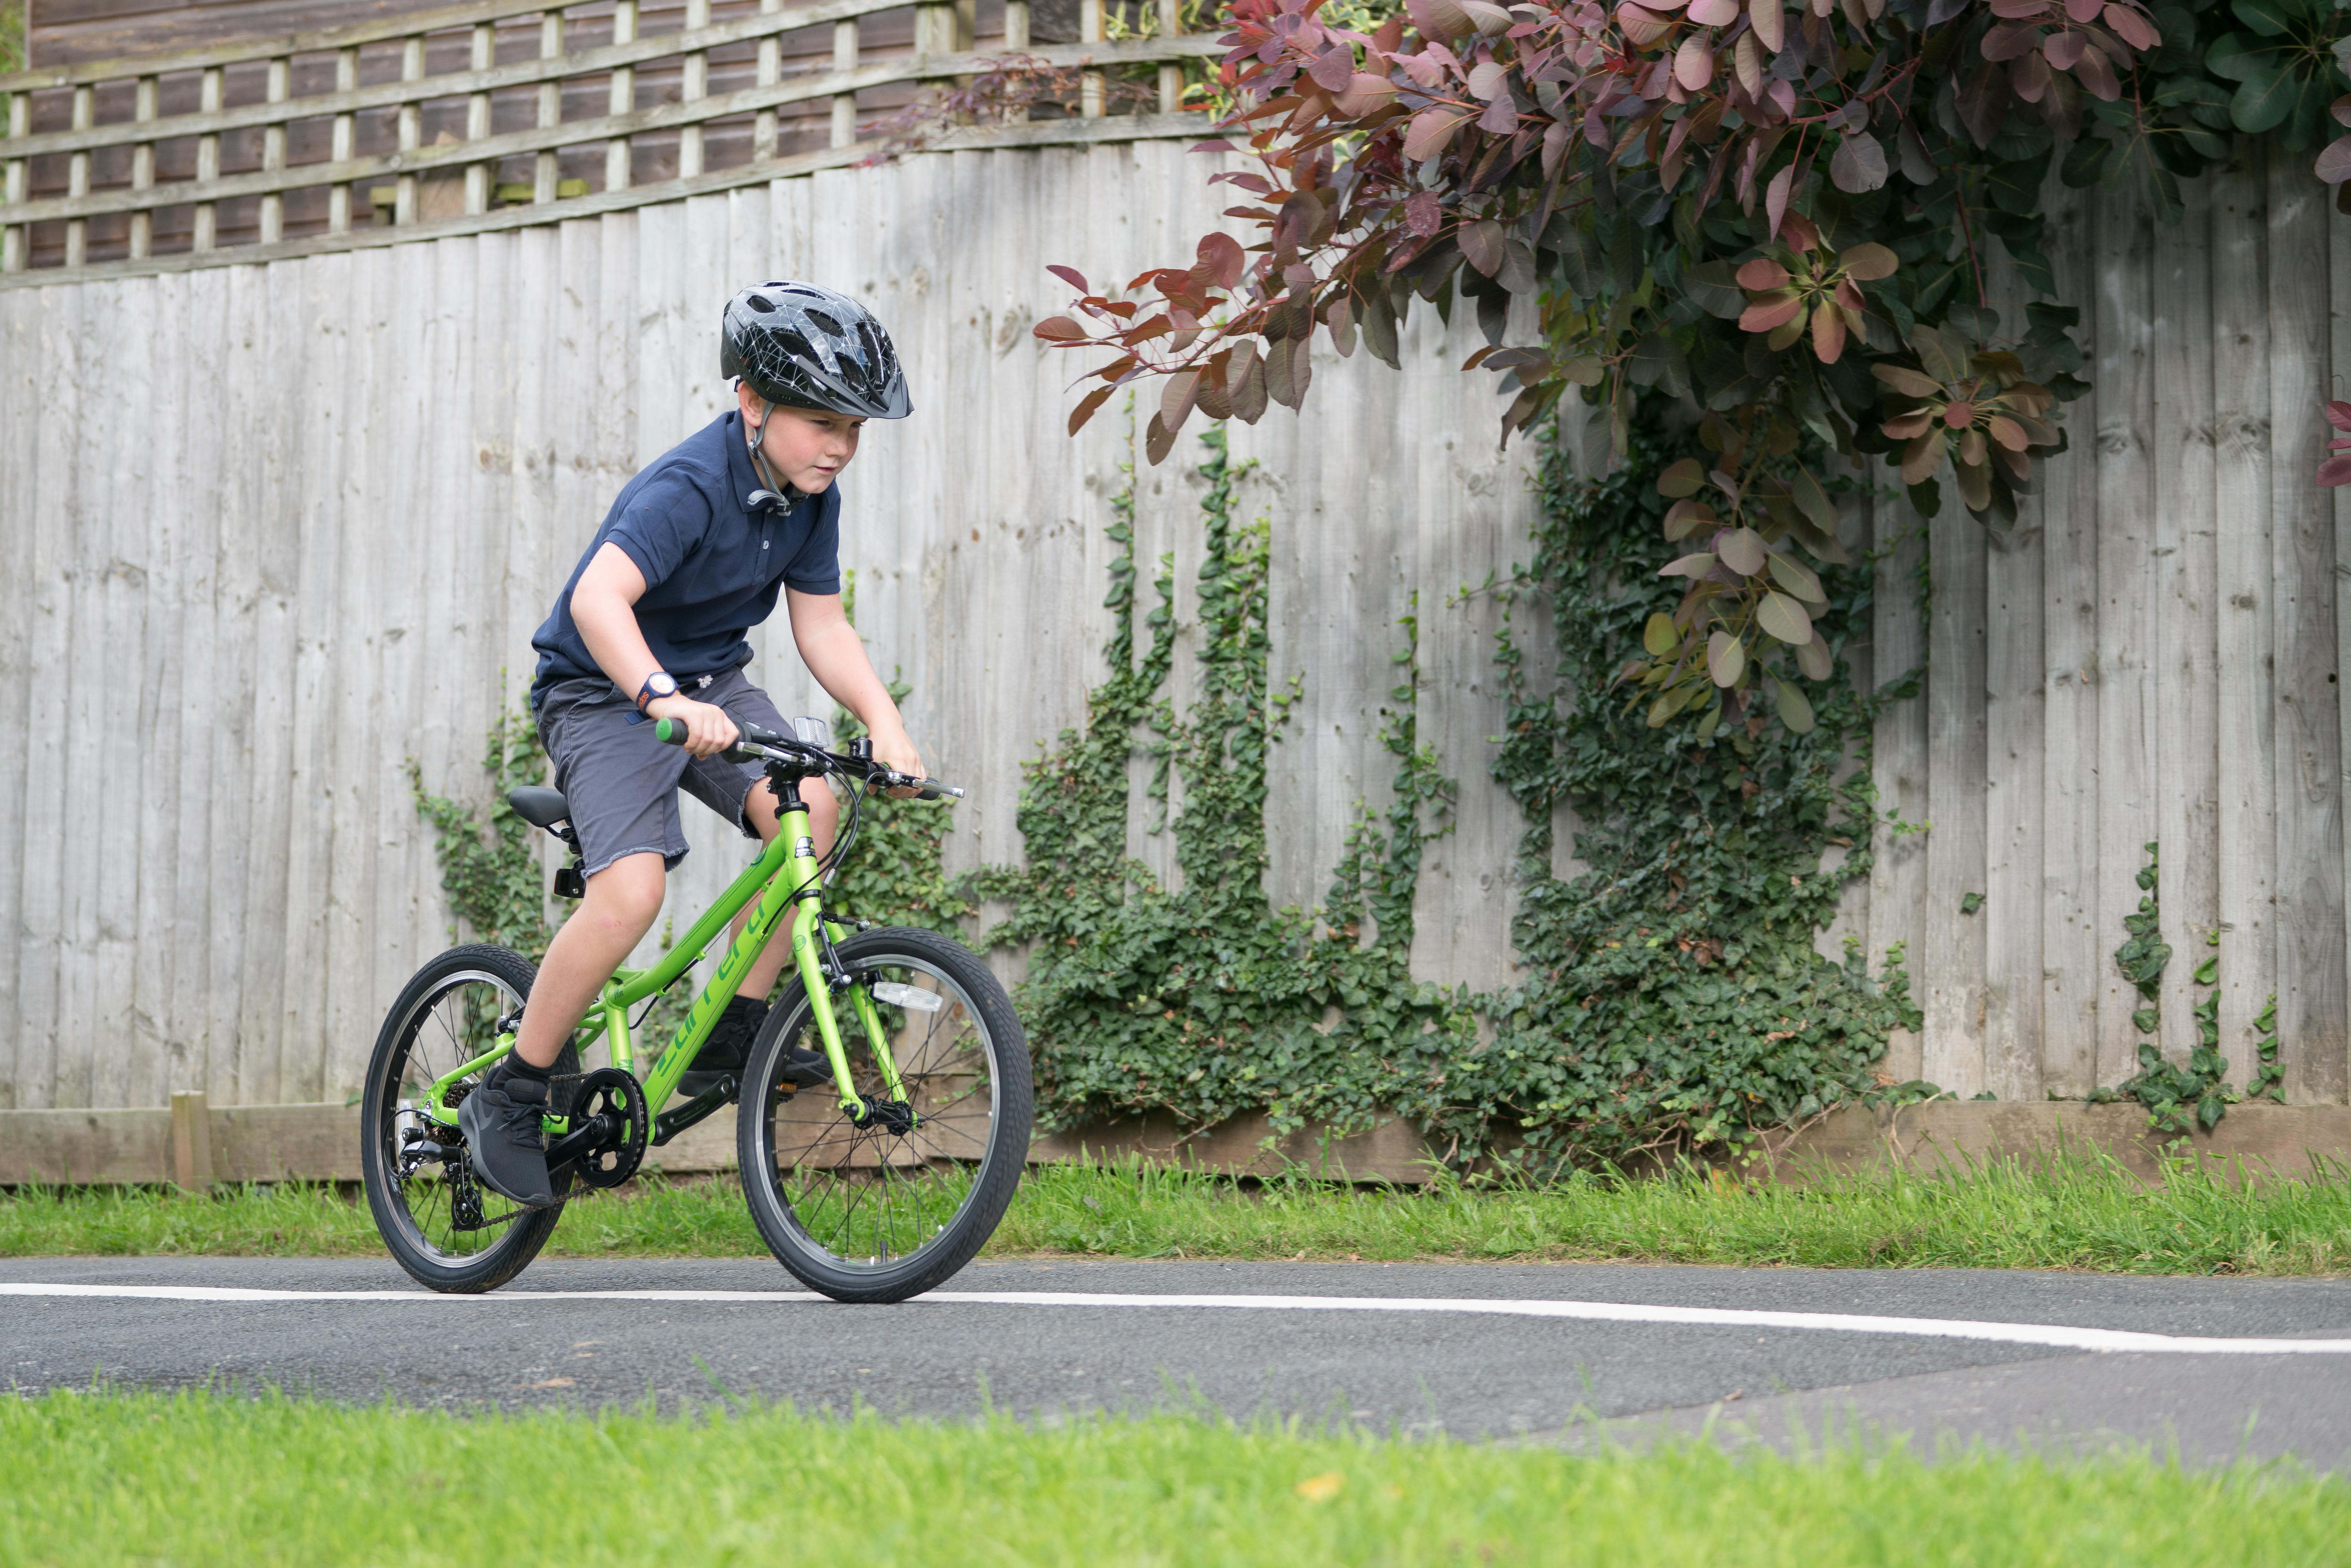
[0,141,1530,1107]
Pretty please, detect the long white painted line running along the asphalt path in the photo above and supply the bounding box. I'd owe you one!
[0,1281,2351,1356]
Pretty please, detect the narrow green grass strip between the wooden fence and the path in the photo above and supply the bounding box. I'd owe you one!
[0,1154,2351,1274]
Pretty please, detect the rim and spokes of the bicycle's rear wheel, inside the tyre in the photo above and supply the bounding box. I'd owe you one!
[376,969,555,1265]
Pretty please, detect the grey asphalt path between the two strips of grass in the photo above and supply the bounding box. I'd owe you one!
[0,1258,2351,1469]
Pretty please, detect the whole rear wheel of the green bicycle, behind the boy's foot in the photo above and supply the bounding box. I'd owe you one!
[360,945,578,1293]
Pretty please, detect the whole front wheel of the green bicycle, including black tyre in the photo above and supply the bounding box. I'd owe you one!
[736,926,1034,1302]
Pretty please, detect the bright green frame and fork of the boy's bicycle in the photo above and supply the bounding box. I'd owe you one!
[423,804,905,1131]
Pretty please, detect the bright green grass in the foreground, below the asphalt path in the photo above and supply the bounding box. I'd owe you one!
[0,1392,2351,1568]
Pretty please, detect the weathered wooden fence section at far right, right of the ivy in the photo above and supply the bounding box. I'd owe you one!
[1850,143,2351,1102]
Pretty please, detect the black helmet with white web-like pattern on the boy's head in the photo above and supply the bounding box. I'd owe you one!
[719,282,915,418]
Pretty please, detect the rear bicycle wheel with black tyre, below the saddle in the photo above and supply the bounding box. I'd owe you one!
[360,943,578,1295]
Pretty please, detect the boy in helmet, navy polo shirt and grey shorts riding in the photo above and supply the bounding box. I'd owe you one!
[459,282,924,1206]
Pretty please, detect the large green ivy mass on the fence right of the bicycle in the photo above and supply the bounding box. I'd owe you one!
[964,416,1933,1175]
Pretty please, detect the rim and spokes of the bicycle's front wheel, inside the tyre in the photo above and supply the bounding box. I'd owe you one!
[764,955,999,1274]
